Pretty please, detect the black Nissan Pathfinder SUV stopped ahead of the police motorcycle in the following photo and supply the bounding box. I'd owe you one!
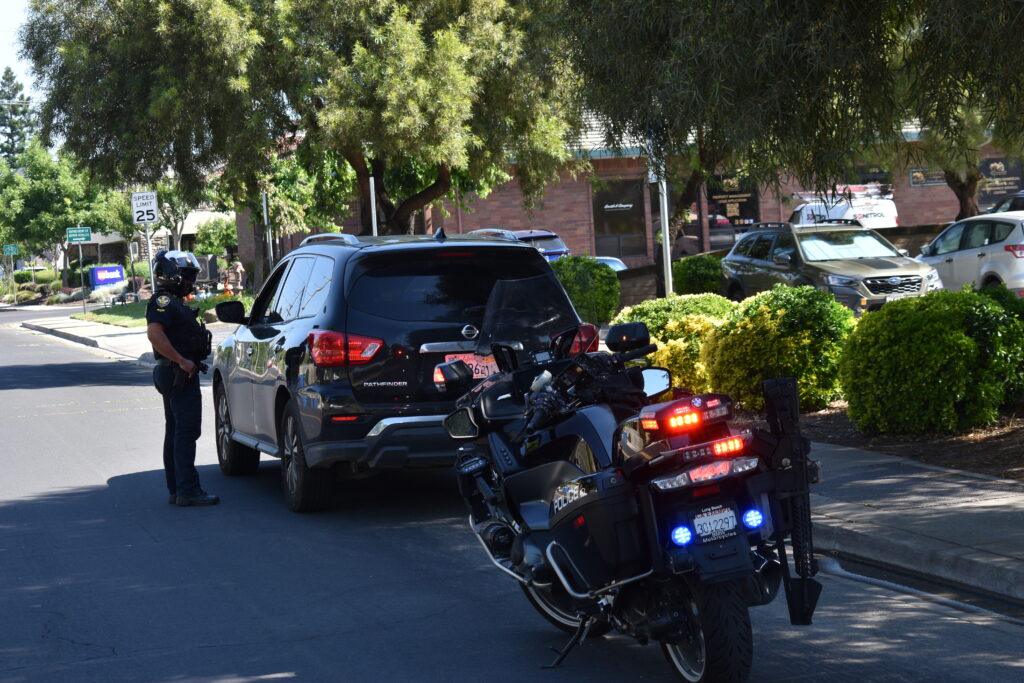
[213,234,581,512]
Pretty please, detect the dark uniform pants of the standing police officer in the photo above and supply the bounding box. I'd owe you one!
[153,365,203,496]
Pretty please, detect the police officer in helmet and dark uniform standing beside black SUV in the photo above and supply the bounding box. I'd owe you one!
[145,249,220,507]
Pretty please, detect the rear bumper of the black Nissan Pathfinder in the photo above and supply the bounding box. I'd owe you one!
[305,415,459,469]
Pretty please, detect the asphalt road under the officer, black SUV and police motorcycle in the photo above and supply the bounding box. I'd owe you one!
[6,310,1024,683]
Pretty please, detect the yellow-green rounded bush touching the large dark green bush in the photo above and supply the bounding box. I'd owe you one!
[700,285,854,411]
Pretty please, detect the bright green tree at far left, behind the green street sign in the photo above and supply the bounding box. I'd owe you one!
[0,141,125,284]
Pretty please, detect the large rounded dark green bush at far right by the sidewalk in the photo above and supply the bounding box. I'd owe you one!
[841,291,1024,434]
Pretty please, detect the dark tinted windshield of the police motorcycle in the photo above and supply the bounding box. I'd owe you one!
[477,272,580,357]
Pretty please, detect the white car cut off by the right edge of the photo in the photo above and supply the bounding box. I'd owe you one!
[918,211,1024,294]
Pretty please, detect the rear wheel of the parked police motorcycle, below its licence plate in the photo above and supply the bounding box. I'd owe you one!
[662,584,754,683]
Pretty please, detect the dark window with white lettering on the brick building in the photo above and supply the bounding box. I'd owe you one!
[594,178,647,257]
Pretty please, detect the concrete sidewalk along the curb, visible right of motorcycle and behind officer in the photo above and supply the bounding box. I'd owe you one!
[12,316,1024,600]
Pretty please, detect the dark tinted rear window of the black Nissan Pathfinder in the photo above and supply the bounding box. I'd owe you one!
[348,248,549,323]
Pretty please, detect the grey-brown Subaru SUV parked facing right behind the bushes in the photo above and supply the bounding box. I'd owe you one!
[722,223,942,314]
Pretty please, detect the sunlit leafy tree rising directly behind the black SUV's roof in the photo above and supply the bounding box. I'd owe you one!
[281,0,578,232]
